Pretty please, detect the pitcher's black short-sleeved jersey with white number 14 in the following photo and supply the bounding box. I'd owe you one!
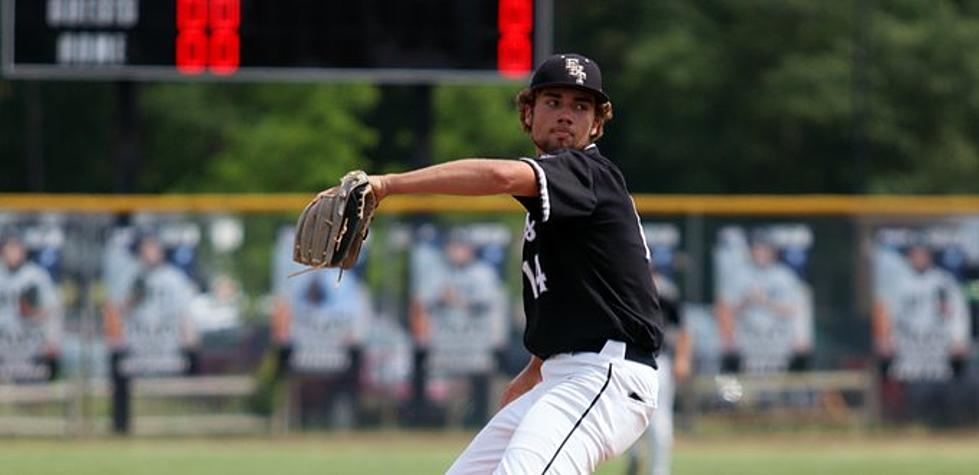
[517,145,663,359]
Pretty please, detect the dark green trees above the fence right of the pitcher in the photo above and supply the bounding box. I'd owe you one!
[558,0,979,193]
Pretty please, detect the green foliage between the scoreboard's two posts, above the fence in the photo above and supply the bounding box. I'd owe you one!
[143,84,377,192]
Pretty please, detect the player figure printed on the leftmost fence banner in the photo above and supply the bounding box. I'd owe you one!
[0,232,63,379]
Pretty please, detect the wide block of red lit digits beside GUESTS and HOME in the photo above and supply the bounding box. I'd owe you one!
[176,0,241,75]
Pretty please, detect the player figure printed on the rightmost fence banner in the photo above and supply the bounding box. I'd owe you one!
[873,244,970,381]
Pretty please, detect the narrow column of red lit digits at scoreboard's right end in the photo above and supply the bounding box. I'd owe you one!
[496,0,534,78]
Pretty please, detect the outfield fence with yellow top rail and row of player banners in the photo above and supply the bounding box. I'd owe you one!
[0,194,979,435]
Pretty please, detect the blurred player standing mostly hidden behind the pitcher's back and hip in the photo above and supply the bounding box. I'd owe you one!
[626,271,692,475]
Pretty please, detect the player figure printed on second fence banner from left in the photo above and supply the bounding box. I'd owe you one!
[104,235,198,374]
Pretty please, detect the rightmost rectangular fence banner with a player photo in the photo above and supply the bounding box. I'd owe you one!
[873,225,975,382]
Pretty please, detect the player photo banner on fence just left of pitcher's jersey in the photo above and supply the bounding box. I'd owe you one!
[410,224,511,382]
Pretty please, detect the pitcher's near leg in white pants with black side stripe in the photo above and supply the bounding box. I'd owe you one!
[494,353,657,475]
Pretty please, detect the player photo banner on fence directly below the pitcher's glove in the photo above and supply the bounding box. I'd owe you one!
[272,227,373,374]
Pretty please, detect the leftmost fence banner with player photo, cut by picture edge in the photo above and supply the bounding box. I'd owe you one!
[0,224,64,383]
